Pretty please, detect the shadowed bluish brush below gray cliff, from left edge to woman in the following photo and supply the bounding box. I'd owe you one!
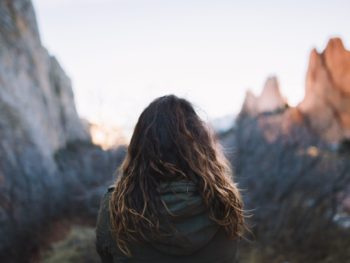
[0,141,125,263]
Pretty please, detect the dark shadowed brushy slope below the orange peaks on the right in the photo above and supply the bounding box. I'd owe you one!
[230,115,350,262]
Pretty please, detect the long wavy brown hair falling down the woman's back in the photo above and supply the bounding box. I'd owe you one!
[109,95,245,256]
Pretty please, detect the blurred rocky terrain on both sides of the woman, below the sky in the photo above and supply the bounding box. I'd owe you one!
[0,0,350,263]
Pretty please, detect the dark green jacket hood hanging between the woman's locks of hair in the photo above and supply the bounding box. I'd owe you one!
[152,180,219,255]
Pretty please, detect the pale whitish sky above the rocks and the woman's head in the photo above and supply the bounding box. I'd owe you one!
[33,0,350,132]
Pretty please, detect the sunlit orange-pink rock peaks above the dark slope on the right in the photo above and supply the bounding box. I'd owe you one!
[241,38,350,144]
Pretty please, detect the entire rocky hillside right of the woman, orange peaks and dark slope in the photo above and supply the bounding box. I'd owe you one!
[228,39,350,262]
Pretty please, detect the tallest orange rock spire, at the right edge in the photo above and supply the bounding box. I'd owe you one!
[298,38,350,143]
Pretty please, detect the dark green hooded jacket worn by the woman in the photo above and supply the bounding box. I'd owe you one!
[96,180,237,263]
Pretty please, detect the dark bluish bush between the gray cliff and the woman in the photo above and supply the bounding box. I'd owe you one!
[55,142,126,222]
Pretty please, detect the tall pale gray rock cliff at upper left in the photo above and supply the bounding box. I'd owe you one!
[0,0,89,159]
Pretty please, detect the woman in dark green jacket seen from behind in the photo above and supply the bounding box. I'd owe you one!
[96,95,244,263]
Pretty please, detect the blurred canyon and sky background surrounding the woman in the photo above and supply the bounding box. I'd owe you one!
[0,0,350,263]
